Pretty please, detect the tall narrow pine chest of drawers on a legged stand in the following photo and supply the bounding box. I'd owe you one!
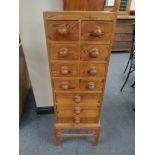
[44,11,116,145]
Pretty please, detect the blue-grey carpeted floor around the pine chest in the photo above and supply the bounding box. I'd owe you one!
[19,53,135,155]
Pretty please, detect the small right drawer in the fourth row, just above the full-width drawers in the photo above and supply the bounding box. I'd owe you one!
[80,79,104,91]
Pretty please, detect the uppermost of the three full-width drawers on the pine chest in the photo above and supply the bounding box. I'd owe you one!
[55,93,102,108]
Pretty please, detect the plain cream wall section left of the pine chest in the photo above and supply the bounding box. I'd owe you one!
[19,0,62,107]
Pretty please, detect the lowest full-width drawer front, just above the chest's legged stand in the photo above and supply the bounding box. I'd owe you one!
[58,117,99,124]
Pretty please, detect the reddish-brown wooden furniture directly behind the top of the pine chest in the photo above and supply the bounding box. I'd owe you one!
[63,0,104,11]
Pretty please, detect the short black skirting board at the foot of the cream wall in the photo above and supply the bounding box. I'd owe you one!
[36,106,54,115]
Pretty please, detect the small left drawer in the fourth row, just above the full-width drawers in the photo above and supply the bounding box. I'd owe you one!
[53,78,79,91]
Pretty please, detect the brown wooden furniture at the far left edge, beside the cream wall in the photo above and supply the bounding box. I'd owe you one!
[19,38,30,116]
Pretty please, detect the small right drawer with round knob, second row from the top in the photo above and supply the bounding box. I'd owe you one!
[80,44,109,61]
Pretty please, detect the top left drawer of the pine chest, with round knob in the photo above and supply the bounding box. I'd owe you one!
[47,21,79,41]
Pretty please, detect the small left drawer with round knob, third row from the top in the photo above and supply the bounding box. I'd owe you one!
[51,63,78,77]
